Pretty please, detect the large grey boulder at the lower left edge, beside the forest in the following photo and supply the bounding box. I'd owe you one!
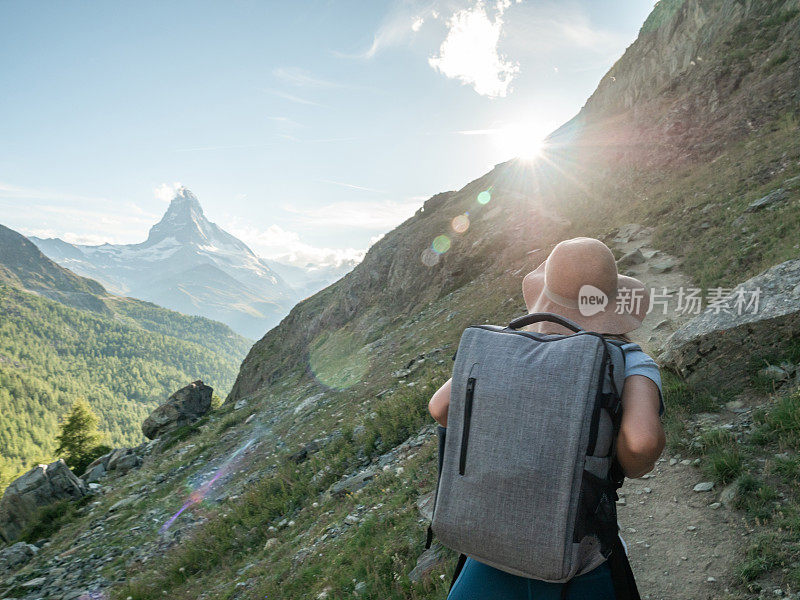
[0,460,86,542]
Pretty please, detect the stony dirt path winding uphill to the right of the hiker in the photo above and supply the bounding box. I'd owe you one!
[609,225,747,600]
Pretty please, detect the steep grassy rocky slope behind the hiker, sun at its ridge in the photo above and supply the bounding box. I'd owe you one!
[1,0,800,600]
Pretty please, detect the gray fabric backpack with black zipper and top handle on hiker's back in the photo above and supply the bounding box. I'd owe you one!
[426,313,635,597]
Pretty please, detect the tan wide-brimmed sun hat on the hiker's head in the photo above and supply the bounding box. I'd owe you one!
[522,237,650,335]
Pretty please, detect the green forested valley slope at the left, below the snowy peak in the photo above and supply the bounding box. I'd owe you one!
[0,226,249,489]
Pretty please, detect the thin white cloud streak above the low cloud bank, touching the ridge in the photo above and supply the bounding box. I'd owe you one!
[283,199,422,231]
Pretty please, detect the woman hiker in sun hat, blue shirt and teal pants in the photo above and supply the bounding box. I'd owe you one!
[428,237,665,600]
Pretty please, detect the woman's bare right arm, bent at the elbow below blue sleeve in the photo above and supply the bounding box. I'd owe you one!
[617,375,666,477]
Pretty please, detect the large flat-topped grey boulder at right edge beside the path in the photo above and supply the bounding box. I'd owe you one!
[661,259,800,385]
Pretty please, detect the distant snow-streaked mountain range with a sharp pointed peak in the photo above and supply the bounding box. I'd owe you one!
[30,188,348,339]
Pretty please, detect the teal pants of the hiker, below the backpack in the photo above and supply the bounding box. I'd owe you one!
[447,558,614,600]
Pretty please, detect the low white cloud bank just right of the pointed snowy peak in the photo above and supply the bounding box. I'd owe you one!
[224,219,366,268]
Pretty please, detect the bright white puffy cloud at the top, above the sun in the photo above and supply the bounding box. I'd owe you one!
[428,0,519,98]
